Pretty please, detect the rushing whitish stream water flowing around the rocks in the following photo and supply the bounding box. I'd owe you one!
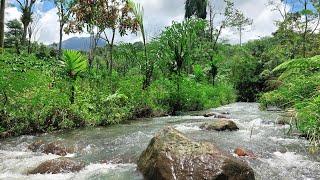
[0,103,320,180]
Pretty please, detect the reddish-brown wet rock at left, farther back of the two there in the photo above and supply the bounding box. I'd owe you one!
[28,140,74,156]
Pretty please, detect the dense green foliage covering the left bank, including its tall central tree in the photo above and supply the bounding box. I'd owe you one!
[0,17,236,135]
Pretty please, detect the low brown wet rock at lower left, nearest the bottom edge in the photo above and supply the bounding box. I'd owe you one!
[28,157,84,174]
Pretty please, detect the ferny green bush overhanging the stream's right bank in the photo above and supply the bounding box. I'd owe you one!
[260,56,320,147]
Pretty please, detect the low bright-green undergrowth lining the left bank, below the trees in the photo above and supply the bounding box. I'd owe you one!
[0,52,236,137]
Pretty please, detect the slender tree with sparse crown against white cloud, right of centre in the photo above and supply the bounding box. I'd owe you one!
[230,10,252,46]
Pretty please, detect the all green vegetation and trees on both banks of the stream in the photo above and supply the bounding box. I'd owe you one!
[0,0,320,150]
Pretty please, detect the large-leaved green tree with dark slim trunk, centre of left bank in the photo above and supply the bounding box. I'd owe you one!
[159,19,206,111]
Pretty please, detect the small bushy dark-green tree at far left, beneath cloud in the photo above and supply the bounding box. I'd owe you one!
[4,19,23,54]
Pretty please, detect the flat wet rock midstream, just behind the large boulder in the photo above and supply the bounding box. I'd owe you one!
[200,119,239,131]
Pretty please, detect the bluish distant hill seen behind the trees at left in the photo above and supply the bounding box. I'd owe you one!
[62,37,106,51]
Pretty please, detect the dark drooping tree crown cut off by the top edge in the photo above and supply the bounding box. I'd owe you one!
[185,0,208,19]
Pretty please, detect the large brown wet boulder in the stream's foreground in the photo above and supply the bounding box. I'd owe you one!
[138,127,255,180]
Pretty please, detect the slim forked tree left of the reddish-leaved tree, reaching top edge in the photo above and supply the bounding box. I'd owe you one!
[54,0,71,58]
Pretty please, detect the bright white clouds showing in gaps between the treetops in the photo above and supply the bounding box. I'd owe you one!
[6,0,281,44]
